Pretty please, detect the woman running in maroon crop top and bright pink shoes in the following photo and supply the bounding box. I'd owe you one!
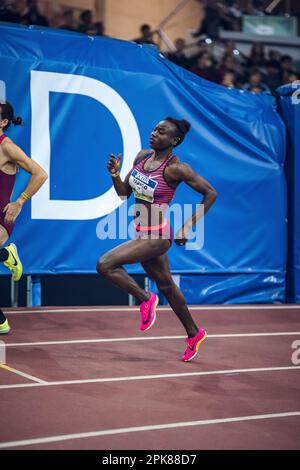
[97,117,217,362]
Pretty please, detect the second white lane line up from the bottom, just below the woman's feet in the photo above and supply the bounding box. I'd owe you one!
[0,366,300,390]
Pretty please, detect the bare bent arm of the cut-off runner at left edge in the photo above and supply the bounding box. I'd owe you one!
[2,141,48,224]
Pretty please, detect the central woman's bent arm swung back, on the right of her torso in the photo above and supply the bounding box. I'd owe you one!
[168,163,218,245]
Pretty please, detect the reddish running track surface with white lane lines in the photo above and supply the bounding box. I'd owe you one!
[0,306,300,450]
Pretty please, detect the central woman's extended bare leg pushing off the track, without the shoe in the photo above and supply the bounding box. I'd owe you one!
[142,253,198,338]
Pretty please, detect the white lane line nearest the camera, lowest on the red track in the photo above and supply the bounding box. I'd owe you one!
[0,411,300,449]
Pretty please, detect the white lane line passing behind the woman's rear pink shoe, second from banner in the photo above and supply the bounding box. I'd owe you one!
[5,331,300,348]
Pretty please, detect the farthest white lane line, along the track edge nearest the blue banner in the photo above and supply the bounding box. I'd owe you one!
[5,304,300,315]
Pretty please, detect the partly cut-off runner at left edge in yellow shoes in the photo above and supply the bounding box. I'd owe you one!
[0,102,48,334]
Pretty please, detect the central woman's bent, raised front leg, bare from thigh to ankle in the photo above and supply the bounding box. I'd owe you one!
[97,238,170,302]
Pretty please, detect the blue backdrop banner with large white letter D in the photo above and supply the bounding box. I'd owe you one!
[0,25,286,302]
